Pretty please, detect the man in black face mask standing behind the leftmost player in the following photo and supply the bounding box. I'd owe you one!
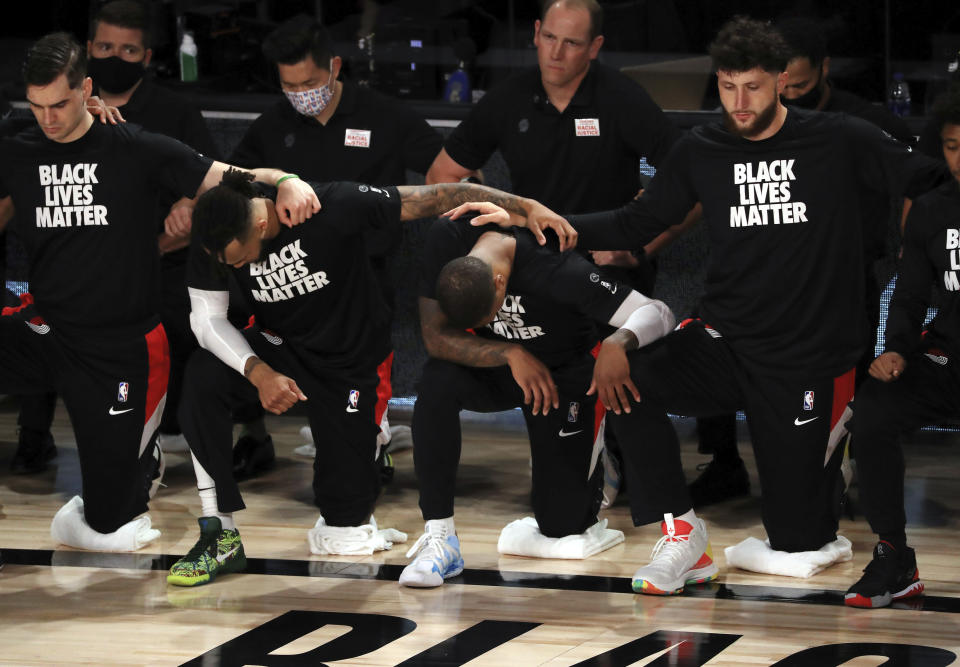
[12,0,217,480]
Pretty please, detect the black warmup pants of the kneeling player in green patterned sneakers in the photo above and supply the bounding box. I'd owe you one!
[180,325,382,526]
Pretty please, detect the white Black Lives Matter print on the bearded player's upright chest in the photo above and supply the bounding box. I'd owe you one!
[730,160,807,227]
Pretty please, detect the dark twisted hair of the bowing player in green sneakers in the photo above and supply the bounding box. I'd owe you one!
[191,169,257,262]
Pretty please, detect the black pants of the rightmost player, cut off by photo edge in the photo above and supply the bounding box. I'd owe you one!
[847,351,960,533]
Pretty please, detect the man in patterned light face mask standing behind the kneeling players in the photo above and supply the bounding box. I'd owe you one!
[231,15,442,486]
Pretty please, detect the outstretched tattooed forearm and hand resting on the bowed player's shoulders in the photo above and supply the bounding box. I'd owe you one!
[397,183,577,250]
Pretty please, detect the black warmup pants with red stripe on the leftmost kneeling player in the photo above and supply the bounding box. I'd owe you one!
[0,317,170,533]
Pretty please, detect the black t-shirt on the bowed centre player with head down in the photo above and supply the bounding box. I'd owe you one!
[420,218,631,368]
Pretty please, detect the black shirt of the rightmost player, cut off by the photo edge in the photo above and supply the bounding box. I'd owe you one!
[886,180,960,356]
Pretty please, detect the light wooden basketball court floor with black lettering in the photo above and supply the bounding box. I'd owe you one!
[0,402,960,667]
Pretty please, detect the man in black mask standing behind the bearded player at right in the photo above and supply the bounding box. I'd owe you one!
[690,18,913,507]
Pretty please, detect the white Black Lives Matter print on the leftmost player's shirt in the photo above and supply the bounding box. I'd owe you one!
[36,162,109,227]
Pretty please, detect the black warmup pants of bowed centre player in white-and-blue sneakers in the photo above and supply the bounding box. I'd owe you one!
[413,355,603,537]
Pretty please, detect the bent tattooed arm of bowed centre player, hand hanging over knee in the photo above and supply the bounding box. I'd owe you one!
[420,297,560,414]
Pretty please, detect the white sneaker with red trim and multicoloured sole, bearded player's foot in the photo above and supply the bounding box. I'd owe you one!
[633,514,719,595]
